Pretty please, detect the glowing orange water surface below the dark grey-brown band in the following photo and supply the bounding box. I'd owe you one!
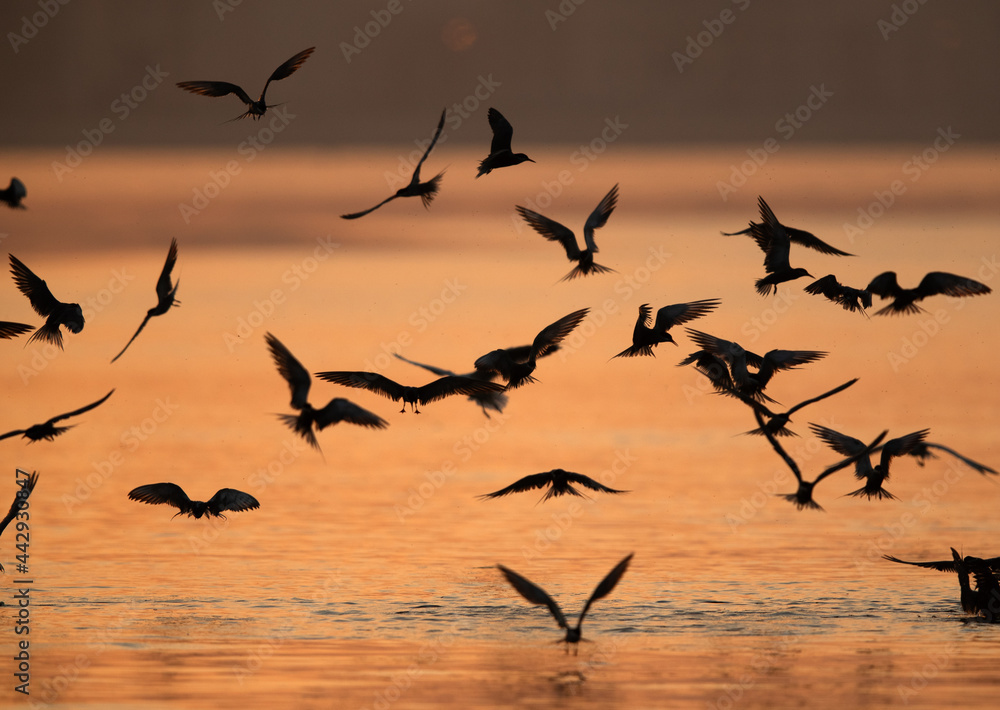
[0,151,1000,708]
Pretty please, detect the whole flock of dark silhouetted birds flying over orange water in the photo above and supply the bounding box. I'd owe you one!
[0,47,1000,649]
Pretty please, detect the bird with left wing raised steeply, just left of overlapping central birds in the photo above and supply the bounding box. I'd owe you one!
[264,333,389,450]
